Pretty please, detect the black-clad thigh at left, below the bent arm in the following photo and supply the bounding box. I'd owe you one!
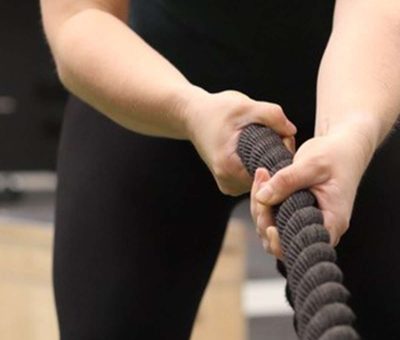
[54,99,235,340]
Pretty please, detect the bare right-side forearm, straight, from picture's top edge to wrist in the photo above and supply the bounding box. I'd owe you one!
[315,0,400,158]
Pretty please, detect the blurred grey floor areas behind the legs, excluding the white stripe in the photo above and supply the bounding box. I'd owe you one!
[0,179,296,340]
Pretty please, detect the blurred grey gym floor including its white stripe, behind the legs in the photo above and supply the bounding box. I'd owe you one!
[0,173,296,340]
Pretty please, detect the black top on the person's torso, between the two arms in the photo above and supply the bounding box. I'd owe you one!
[131,0,334,140]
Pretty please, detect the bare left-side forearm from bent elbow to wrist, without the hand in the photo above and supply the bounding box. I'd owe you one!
[44,9,203,139]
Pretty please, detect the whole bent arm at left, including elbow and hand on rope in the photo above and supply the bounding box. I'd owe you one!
[41,0,296,195]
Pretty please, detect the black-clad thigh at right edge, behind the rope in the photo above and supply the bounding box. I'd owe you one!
[338,131,400,340]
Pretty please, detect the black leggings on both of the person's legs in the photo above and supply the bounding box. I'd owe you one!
[54,94,400,340]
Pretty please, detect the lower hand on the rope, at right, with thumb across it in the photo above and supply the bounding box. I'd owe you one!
[251,129,372,259]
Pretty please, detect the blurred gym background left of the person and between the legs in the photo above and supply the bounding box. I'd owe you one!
[0,0,295,340]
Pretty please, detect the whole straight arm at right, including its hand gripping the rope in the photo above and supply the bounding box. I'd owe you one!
[251,0,400,257]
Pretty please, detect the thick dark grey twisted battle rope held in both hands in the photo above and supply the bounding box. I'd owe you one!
[237,124,360,340]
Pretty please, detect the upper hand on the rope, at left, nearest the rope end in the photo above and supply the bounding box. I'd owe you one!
[183,87,296,196]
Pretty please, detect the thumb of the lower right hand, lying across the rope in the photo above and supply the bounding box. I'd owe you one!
[256,161,329,205]
